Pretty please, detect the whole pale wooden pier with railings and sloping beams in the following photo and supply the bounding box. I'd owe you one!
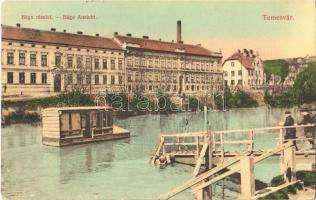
[152,124,315,200]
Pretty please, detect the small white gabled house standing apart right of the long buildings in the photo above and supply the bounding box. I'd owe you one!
[223,49,265,89]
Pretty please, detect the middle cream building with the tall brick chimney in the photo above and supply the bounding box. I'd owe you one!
[114,21,223,95]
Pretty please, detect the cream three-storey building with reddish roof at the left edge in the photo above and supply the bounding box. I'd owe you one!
[1,24,125,96]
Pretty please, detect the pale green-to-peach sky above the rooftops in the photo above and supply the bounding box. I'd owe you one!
[1,0,316,60]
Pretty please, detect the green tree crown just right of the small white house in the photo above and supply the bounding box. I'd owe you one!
[263,59,289,82]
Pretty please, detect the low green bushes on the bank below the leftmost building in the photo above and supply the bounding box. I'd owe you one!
[1,91,94,109]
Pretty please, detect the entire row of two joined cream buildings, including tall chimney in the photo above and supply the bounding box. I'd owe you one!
[1,21,223,97]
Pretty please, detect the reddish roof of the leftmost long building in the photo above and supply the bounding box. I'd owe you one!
[2,26,122,50]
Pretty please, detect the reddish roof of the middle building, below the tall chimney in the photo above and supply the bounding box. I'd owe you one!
[115,35,222,57]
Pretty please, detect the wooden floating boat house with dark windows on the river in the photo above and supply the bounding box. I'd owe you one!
[42,106,130,146]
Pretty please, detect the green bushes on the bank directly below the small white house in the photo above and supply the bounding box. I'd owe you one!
[215,87,258,108]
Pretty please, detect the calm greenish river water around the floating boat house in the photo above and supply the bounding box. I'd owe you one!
[1,107,298,200]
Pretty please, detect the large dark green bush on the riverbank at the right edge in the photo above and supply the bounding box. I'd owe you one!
[265,62,316,108]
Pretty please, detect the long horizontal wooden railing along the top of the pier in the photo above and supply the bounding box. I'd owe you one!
[156,124,315,162]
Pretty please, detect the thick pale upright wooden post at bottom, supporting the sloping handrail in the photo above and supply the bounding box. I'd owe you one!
[240,154,255,199]
